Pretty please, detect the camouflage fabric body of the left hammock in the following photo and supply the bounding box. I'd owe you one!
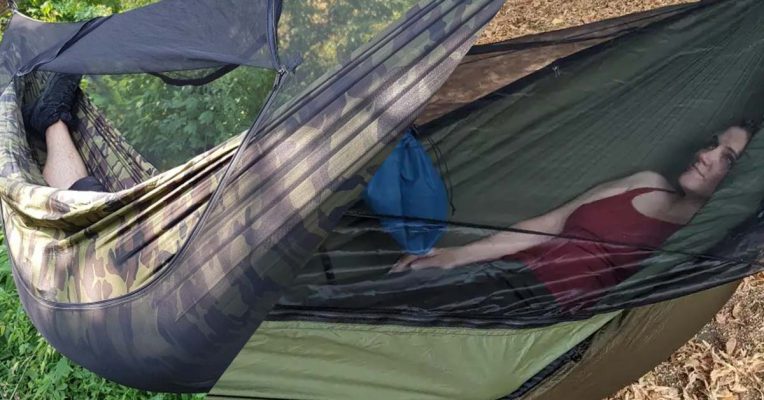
[0,0,502,391]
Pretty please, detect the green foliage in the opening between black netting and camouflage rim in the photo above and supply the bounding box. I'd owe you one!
[83,67,276,172]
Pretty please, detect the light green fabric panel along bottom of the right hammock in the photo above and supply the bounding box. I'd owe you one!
[209,313,619,400]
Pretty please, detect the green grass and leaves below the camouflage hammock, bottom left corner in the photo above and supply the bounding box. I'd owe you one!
[0,234,205,400]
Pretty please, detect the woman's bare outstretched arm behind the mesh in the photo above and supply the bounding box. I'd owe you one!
[390,171,666,272]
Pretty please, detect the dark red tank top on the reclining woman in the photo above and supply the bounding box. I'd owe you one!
[506,188,682,304]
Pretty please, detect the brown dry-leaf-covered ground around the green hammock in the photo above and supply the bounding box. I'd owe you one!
[480,0,764,400]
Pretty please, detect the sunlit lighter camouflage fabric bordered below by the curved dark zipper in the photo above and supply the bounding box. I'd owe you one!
[0,75,235,303]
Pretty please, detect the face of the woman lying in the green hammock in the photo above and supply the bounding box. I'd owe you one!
[679,126,750,198]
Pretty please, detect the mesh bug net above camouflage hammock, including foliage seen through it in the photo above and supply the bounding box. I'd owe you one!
[11,0,430,177]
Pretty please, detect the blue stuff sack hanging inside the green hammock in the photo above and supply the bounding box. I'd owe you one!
[364,130,448,254]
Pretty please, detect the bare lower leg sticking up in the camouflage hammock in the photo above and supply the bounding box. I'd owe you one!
[42,121,88,189]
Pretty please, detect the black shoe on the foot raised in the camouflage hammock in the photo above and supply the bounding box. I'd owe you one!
[23,74,82,138]
